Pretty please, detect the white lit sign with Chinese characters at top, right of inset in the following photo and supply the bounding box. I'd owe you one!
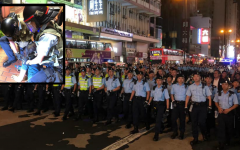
[89,0,103,15]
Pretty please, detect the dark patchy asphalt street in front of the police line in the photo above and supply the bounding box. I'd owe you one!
[0,99,240,150]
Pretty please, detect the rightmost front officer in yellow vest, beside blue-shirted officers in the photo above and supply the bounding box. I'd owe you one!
[92,67,105,123]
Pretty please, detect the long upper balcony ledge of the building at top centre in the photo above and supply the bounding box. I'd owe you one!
[109,0,161,17]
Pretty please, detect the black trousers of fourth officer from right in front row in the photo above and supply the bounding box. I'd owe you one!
[153,101,166,134]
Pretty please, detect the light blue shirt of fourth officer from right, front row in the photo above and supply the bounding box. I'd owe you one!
[151,86,169,101]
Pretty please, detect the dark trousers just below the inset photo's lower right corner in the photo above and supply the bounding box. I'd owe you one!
[53,86,62,114]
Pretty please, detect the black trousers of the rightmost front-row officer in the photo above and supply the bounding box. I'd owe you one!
[217,112,234,142]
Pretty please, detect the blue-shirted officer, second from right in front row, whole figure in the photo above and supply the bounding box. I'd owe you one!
[185,72,212,145]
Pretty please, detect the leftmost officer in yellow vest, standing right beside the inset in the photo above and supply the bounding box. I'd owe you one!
[61,67,77,120]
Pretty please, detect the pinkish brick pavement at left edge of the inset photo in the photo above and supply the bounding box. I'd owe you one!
[0,48,21,83]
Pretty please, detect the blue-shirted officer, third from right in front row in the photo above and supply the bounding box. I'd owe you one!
[171,74,187,139]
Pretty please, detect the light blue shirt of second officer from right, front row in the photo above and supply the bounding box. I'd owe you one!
[186,83,212,102]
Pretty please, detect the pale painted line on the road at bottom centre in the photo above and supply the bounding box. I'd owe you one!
[102,127,154,150]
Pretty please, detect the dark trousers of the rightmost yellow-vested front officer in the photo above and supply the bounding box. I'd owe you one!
[93,91,102,120]
